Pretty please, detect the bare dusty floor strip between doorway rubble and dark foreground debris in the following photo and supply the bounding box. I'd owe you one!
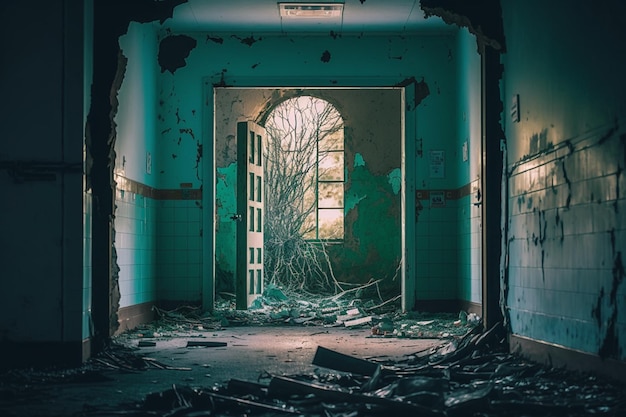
[0,326,438,417]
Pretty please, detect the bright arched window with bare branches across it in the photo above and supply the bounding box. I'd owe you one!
[265,96,345,240]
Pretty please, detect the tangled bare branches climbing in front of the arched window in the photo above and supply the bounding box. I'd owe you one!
[264,96,343,294]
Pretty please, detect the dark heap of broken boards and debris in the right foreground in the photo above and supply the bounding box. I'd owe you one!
[81,325,626,417]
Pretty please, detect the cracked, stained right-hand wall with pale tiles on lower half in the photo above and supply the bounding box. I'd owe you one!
[502,1,626,361]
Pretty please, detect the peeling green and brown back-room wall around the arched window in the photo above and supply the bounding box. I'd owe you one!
[213,87,406,308]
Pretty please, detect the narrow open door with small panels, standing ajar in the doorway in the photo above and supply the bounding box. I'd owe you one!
[235,122,265,310]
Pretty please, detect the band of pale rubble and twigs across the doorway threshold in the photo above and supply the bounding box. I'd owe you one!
[117,284,481,347]
